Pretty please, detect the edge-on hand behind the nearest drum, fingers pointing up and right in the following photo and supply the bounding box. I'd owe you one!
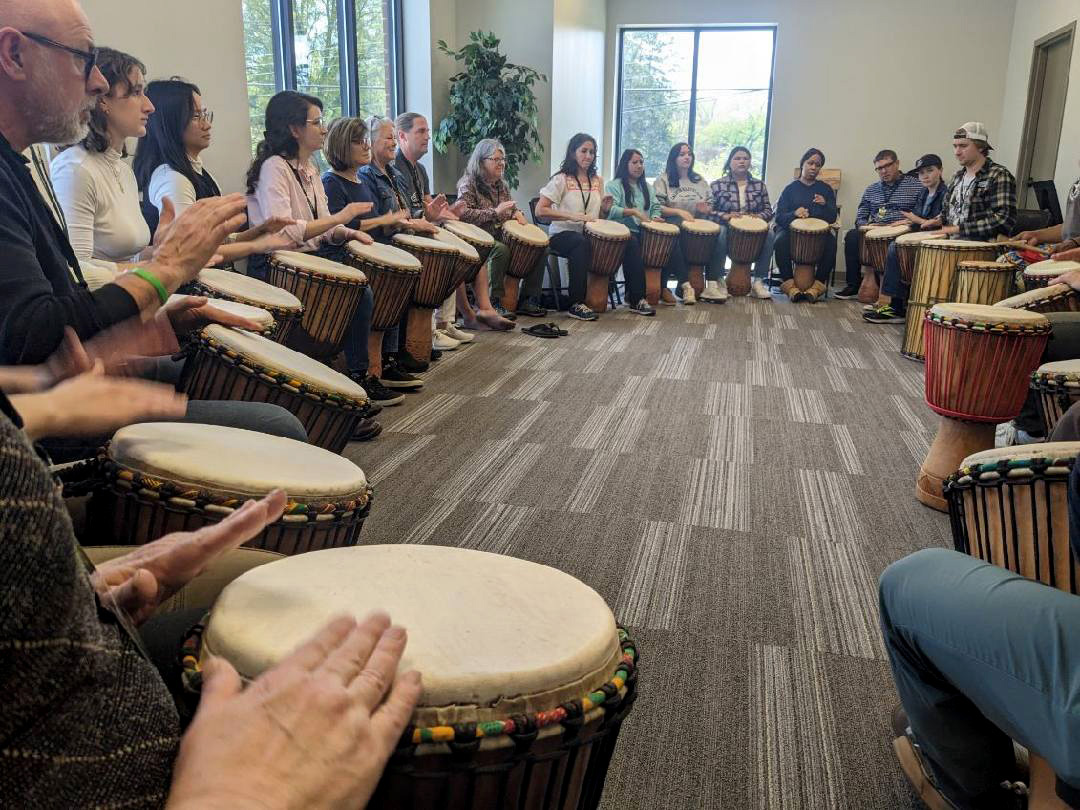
[91,489,286,624]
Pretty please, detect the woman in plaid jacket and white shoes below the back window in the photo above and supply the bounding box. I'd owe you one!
[701,146,773,300]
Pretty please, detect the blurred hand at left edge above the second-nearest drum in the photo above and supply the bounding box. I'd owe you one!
[11,361,187,440]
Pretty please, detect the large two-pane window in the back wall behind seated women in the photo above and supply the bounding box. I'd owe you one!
[613,27,775,179]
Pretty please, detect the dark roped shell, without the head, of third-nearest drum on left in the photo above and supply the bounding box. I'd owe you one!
[178,340,368,453]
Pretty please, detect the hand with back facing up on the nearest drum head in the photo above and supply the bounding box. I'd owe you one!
[167,613,422,810]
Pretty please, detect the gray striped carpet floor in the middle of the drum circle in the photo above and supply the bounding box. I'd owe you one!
[347,298,949,810]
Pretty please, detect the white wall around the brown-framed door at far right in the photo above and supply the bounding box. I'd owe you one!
[990,0,1080,212]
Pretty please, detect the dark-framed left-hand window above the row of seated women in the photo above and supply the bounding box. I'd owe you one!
[243,0,402,155]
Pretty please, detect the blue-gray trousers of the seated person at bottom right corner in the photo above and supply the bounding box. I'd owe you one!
[879,549,1080,809]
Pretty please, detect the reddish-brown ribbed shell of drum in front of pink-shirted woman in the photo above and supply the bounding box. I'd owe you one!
[267,258,367,357]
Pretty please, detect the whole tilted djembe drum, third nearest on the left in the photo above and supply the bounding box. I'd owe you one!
[178,324,369,453]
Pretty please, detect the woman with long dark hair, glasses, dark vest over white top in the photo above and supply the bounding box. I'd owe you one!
[134,77,293,261]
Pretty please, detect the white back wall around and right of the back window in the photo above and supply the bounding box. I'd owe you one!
[605,0,1015,224]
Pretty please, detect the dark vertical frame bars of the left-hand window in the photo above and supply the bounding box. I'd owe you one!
[263,0,405,118]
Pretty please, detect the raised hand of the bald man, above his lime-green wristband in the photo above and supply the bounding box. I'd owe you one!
[149,194,247,288]
